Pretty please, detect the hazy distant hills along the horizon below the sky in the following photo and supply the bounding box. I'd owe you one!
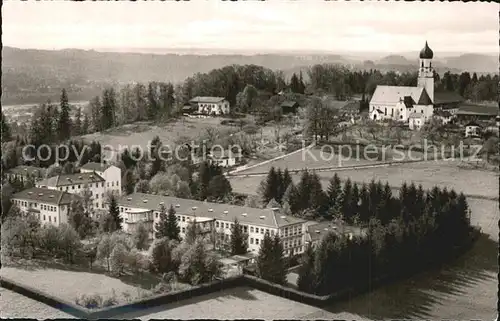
[2,47,498,104]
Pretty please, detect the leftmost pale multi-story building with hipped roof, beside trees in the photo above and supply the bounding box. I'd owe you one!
[11,187,79,226]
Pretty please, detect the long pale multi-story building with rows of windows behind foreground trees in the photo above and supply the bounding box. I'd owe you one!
[118,193,305,255]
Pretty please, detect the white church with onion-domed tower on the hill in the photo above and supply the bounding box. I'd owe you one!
[369,42,454,123]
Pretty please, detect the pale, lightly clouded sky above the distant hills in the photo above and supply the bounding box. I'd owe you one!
[2,0,500,53]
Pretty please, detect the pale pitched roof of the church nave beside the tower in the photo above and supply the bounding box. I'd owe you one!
[370,86,432,106]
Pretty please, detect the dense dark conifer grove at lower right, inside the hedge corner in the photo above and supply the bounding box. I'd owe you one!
[298,184,473,295]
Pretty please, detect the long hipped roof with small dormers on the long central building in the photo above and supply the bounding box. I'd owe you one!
[118,193,304,228]
